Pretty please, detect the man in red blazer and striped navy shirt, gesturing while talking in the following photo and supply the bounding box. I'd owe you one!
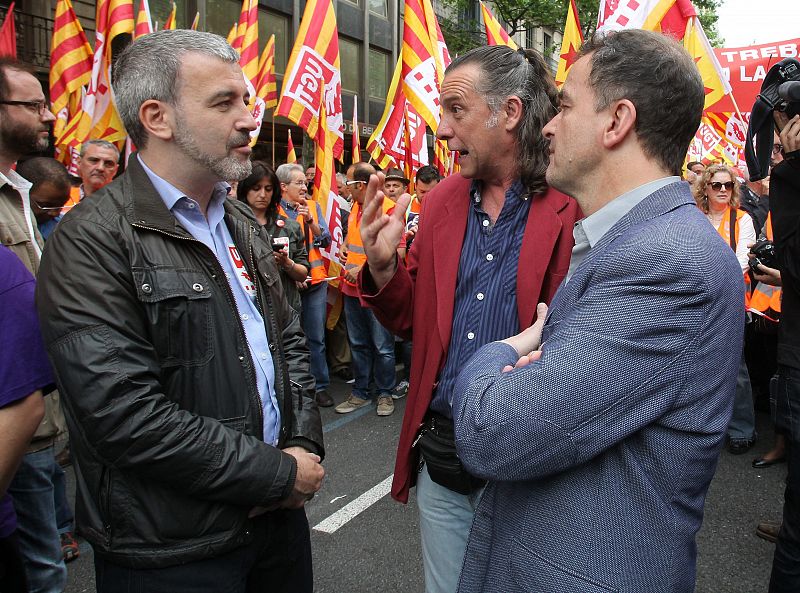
[360,46,579,593]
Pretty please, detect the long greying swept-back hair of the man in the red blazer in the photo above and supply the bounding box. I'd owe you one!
[445,45,559,194]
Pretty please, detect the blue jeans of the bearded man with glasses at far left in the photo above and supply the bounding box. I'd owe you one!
[8,447,67,593]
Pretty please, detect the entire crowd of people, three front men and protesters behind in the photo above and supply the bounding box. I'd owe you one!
[0,25,800,593]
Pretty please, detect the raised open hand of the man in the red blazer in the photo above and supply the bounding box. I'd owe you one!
[361,173,411,289]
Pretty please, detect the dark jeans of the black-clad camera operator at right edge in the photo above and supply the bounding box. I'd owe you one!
[769,366,800,593]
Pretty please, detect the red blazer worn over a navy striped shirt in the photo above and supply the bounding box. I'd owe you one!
[359,175,581,502]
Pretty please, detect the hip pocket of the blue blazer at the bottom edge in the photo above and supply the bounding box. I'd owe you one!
[511,539,619,593]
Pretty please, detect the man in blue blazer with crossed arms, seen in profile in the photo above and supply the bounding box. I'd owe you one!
[453,30,744,593]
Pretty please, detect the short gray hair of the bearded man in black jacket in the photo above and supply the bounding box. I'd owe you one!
[112,29,239,148]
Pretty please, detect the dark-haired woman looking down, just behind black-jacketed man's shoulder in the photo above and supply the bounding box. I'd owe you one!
[236,161,308,313]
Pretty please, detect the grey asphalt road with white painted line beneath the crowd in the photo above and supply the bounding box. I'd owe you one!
[66,380,786,593]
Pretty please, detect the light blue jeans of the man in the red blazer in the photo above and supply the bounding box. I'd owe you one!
[417,465,483,593]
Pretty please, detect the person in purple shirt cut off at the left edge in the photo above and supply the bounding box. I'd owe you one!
[0,245,47,593]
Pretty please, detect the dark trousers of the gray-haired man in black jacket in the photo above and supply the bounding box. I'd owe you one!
[95,509,314,593]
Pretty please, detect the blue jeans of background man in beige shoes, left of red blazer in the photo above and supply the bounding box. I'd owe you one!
[344,295,397,399]
